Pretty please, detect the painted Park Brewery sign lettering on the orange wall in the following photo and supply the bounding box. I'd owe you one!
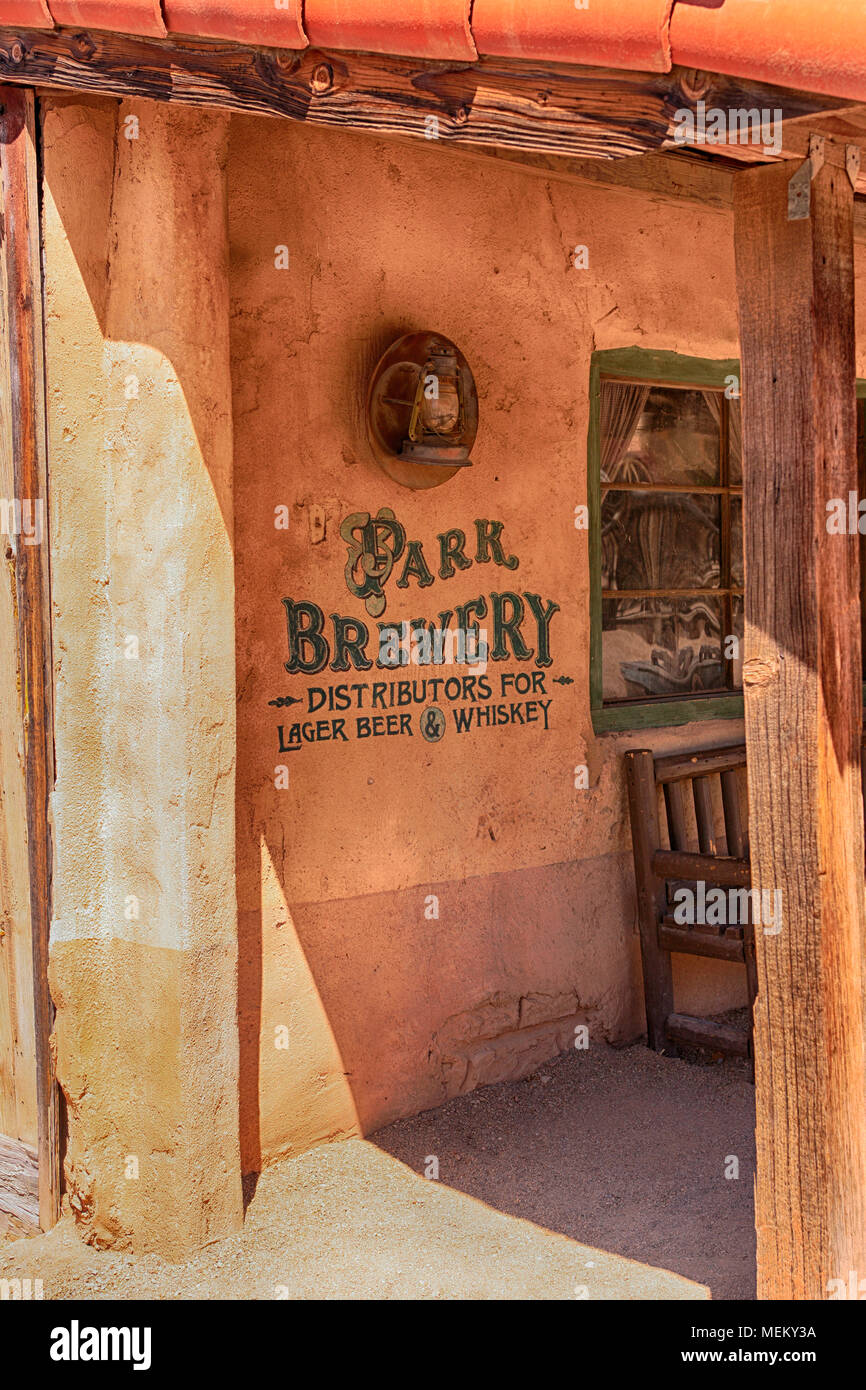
[270,507,571,753]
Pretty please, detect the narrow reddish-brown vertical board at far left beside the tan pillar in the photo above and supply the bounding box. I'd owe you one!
[0,86,60,1230]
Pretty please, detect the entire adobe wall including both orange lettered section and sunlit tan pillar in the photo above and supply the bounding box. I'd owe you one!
[43,86,866,1228]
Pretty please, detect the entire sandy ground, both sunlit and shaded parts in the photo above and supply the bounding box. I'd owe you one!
[0,1045,755,1300]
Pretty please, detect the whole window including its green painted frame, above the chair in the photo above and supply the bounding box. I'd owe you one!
[589,349,744,728]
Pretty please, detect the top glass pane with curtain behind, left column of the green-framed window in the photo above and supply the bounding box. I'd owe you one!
[602,381,721,487]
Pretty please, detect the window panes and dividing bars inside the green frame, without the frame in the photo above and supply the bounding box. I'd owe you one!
[601,377,742,703]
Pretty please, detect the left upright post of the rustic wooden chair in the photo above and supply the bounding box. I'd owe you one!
[626,749,674,1052]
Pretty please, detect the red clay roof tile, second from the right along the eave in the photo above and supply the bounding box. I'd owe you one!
[473,0,674,72]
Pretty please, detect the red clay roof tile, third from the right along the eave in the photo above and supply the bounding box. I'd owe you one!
[304,0,478,61]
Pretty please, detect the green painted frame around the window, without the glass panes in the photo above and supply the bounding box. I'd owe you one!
[587,348,866,734]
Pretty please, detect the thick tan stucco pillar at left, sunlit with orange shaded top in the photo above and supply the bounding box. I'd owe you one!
[43,97,242,1254]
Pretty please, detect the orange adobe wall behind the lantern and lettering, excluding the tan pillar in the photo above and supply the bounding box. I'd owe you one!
[228,118,772,1168]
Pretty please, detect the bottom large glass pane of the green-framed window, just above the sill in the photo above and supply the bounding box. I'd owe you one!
[602,596,726,701]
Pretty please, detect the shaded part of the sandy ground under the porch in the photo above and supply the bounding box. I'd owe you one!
[375,1045,755,1298]
